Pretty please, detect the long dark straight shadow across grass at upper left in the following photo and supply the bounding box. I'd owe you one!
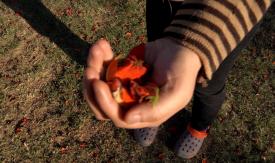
[2,0,90,65]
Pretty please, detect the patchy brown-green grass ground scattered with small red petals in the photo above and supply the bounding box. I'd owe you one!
[0,0,275,162]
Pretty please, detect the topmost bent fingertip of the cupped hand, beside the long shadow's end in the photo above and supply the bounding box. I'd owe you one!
[87,39,113,73]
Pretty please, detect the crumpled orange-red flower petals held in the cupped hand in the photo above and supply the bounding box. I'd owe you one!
[106,44,158,107]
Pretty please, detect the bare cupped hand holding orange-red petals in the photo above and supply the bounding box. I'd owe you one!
[83,38,201,128]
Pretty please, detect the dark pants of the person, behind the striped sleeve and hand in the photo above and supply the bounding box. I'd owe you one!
[146,0,259,131]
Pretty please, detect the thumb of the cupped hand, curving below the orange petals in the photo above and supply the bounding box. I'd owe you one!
[125,80,193,127]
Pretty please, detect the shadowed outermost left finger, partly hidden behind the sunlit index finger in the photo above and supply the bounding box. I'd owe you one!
[83,68,109,120]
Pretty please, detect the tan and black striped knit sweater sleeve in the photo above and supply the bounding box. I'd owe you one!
[165,0,272,80]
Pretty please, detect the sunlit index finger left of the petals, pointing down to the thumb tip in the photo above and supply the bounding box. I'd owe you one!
[93,80,126,127]
